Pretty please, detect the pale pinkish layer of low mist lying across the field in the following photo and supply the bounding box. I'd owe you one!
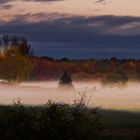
[0,81,140,111]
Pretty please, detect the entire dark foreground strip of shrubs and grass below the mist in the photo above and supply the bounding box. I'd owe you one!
[0,101,140,140]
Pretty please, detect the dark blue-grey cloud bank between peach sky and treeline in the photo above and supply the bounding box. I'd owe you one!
[0,13,140,57]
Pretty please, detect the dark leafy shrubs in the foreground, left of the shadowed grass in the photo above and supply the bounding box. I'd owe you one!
[0,100,100,140]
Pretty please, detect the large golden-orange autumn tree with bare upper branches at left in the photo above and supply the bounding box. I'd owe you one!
[0,35,33,83]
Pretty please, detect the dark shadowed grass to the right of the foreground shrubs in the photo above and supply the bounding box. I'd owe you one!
[100,110,140,140]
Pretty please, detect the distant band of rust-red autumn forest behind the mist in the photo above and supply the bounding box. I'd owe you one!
[30,57,140,83]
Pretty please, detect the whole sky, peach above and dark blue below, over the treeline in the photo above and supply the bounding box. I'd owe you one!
[0,0,140,59]
